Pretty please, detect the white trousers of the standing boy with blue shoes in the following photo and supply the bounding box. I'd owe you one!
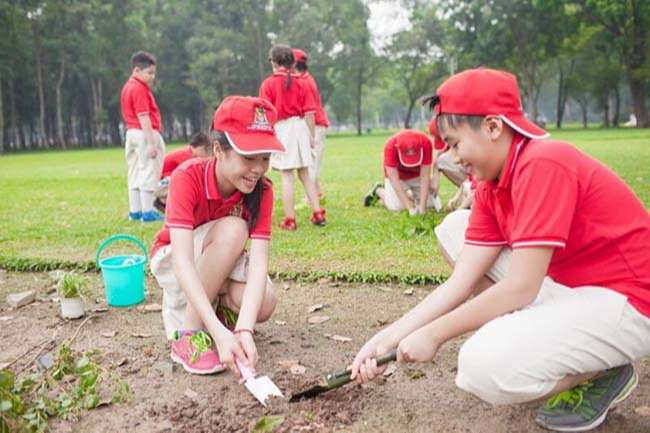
[124,129,165,191]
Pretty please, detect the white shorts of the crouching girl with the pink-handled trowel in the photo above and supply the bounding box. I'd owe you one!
[151,220,248,338]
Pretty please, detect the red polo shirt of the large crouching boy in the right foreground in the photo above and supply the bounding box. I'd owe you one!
[465,136,650,316]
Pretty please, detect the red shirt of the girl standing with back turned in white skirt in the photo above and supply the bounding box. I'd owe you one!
[260,68,316,120]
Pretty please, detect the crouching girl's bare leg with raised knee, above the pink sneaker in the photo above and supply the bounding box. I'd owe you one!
[183,216,248,329]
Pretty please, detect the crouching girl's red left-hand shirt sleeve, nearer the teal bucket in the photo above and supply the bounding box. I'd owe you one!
[165,170,199,230]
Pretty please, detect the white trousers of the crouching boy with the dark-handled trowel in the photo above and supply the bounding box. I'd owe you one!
[435,210,650,404]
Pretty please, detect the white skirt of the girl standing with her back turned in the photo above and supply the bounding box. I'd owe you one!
[271,116,313,170]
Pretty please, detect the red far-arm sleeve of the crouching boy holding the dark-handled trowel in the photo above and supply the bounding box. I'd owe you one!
[465,187,508,247]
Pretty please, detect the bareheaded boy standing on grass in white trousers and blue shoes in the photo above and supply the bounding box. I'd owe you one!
[120,51,165,222]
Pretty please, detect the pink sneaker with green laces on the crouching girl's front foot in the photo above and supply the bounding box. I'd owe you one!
[170,331,226,374]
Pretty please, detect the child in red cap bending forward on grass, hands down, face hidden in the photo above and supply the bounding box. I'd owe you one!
[363,129,441,215]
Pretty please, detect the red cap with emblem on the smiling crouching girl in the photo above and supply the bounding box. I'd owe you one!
[212,96,286,155]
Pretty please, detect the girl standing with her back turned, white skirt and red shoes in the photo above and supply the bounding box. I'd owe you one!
[260,45,327,230]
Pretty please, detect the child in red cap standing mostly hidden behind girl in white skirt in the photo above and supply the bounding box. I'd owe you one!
[292,48,330,198]
